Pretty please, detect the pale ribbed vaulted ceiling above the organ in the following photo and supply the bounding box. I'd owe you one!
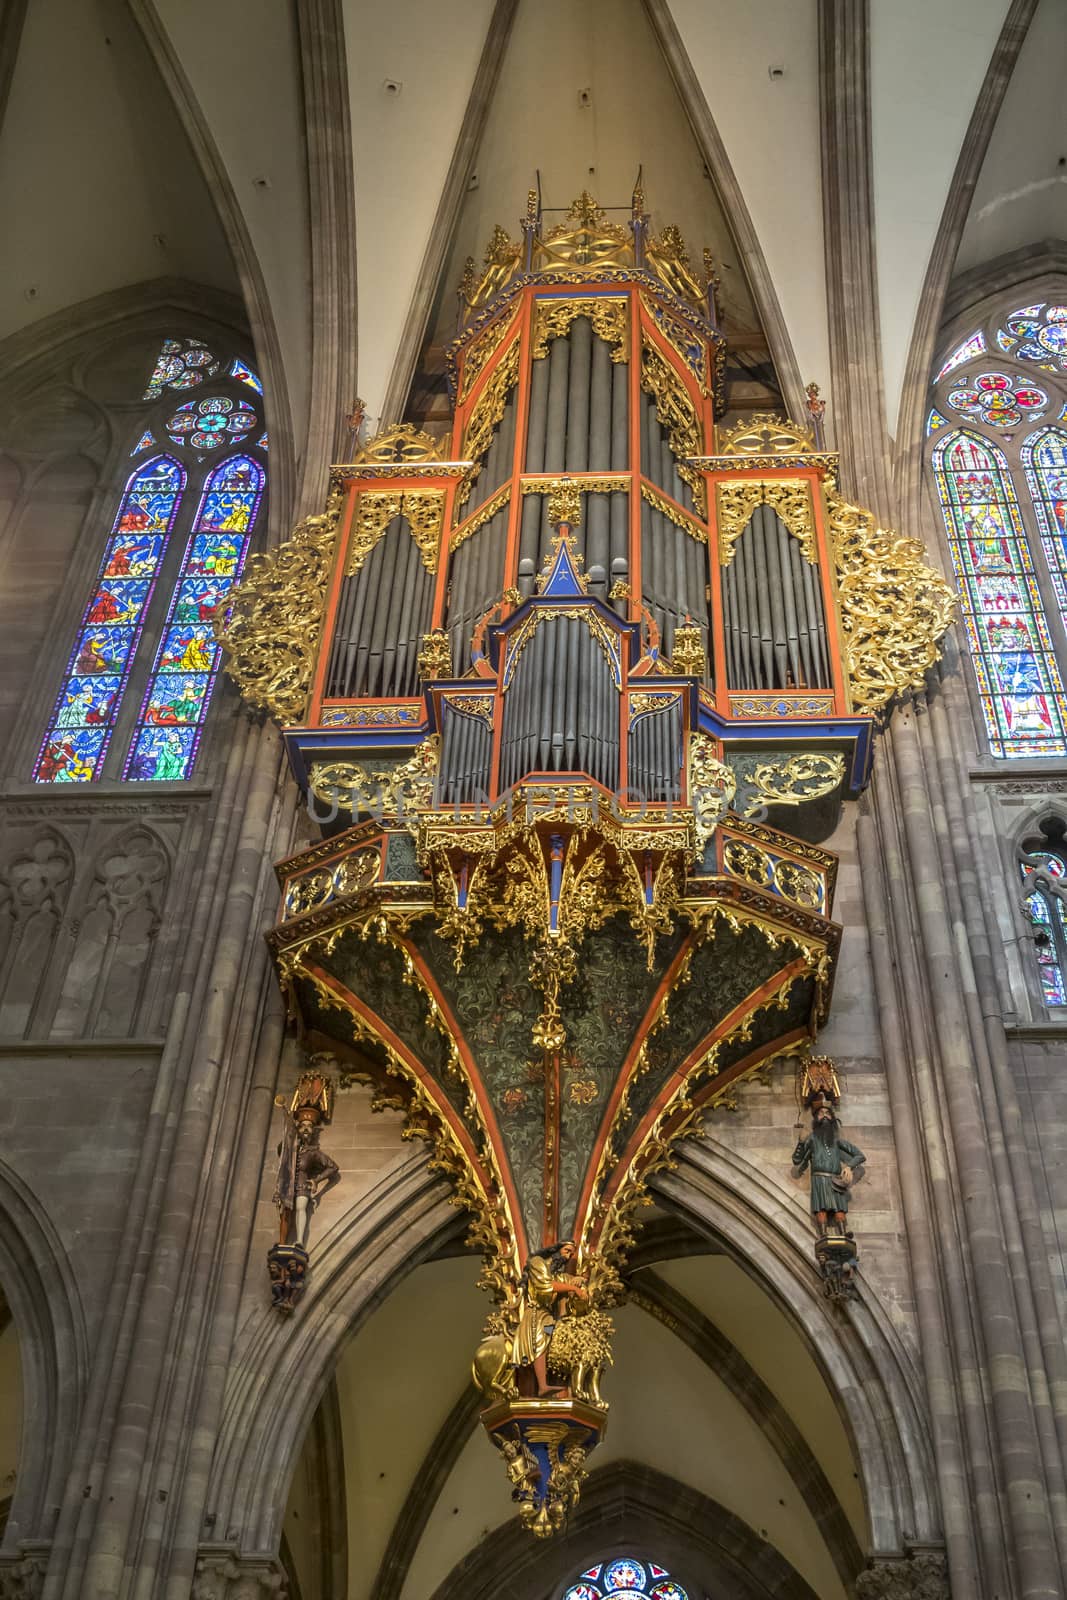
[0,0,1067,492]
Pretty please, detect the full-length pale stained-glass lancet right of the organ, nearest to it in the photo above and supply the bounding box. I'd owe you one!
[933,432,1067,755]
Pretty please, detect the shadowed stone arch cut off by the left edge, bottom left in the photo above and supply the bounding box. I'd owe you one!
[0,1162,88,1549]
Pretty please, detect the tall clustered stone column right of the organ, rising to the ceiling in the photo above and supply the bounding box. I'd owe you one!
[819,0,1067,1600]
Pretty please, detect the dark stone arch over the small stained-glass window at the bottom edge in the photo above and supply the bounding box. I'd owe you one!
[432,1461,816,1600]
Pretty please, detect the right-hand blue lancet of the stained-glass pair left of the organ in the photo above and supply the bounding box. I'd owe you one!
[123,456,266,782]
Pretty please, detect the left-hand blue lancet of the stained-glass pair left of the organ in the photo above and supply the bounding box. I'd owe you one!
[34,456,186,784]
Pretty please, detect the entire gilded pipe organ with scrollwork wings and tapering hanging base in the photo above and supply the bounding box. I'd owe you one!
[221,192,952,1536]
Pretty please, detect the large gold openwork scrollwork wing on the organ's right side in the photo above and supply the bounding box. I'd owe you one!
[827,493,957,712]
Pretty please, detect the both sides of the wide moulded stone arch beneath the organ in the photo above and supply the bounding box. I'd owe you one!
[208,1134,939,1568]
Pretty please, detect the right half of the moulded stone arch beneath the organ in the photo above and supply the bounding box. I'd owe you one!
[653,1128,941,1552]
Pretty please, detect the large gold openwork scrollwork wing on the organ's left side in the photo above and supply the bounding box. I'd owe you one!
[214,486,342,723]
